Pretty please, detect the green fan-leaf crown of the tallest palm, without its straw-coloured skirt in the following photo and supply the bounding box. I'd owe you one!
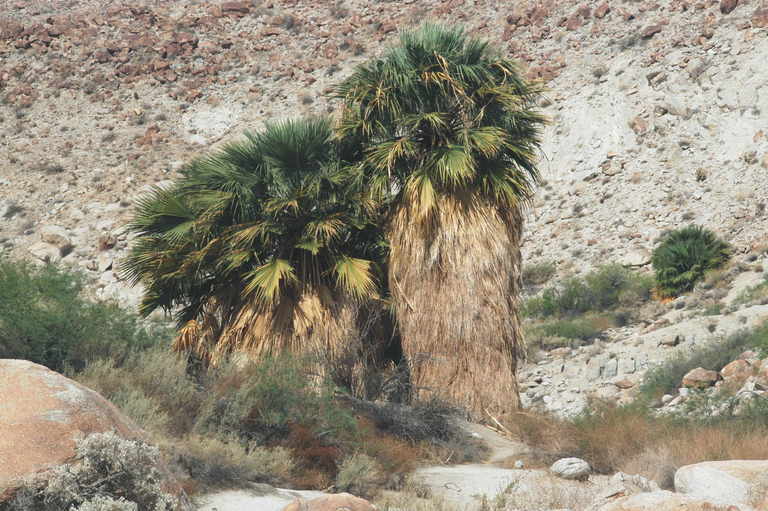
[335,25,544,216]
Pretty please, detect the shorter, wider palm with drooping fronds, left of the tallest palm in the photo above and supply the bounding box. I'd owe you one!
[124,119,392,388]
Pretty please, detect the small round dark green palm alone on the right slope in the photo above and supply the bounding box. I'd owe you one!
[651,225,730,296]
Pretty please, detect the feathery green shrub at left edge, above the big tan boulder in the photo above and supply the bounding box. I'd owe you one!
[0,258,170,371]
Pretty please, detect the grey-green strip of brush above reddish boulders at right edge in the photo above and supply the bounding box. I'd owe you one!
[640,325,768,400]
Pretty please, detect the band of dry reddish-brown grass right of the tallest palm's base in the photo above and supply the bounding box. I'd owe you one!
[508,406,768,488]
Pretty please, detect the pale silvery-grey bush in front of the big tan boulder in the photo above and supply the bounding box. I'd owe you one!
[0,432,180,511]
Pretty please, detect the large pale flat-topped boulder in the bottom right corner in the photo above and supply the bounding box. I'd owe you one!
[675,460,768,504]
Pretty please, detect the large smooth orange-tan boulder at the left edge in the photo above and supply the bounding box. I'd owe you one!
[0,359,142,490]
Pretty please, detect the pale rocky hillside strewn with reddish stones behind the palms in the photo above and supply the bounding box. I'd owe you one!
[0,0,768,410]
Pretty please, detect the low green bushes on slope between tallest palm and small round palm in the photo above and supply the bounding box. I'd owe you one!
[523,264,653,317]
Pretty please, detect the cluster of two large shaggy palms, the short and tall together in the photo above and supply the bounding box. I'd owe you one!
[126,25,544,411]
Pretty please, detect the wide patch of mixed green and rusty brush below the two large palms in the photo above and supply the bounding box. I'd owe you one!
[79,349,474,493]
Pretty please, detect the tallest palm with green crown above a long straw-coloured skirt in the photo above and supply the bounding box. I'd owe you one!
[335,25,545,414]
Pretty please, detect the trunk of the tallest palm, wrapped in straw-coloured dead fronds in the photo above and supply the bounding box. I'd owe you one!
[389,197,523,418]
